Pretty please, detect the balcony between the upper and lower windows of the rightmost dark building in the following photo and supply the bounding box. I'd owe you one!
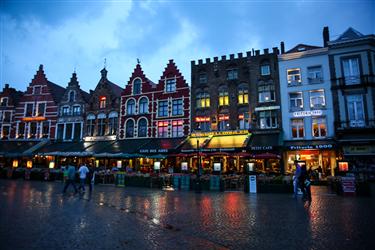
[332,75,375,89]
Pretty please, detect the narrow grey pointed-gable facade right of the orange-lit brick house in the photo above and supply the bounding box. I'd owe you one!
[55,72,90,141]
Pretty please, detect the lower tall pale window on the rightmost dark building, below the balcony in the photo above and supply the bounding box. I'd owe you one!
[346,95,365,127]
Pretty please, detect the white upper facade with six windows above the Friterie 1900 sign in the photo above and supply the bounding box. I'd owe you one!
[279,47,334,141]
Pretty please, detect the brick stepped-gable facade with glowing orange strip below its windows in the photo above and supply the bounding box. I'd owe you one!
[15,65,65,140]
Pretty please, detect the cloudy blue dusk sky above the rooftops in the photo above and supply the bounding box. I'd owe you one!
[0,0,375,91]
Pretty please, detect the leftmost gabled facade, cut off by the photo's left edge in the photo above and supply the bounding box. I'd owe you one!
[0,84,22,140]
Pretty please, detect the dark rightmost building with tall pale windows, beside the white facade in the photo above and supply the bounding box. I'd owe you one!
[328,28,375,168]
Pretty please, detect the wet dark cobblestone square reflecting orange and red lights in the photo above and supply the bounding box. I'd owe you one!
[0,180,375,250]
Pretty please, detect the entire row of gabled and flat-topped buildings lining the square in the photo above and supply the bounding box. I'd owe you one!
[0,27,375,176]
